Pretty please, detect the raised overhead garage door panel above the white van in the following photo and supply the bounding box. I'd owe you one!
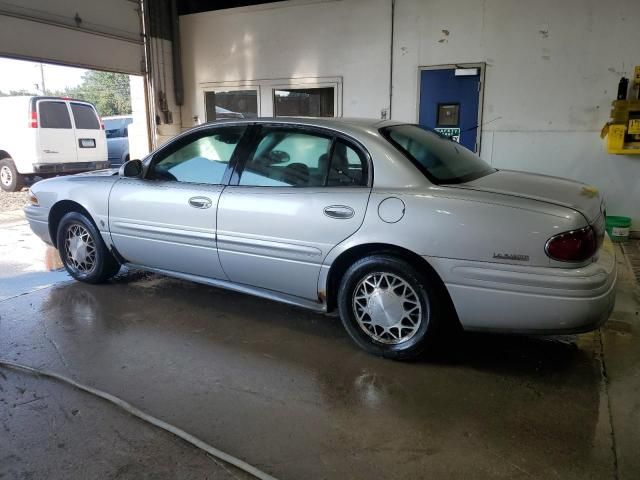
[0,0,144,74]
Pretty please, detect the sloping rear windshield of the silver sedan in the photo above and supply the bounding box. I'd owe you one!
[380,125,495,184]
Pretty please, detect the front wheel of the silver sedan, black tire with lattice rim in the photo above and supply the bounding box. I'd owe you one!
[56,212,120,283]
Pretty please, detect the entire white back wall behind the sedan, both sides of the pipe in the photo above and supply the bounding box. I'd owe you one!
[180,0,640,230]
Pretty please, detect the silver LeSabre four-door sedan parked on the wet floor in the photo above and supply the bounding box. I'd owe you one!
[25,118,616,359]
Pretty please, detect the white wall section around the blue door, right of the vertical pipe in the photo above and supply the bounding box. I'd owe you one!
[393,0,640,230]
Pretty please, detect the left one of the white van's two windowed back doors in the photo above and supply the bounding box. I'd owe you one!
[37,100,78,163]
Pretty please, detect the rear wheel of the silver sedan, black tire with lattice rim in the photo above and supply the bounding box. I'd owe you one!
[338,254,444,360]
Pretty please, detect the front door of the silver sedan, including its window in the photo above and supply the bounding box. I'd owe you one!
[109,125,247,279]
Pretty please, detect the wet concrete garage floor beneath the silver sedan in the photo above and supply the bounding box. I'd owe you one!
[0,215,640,479]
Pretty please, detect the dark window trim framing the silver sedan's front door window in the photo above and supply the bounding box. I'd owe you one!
[141,123,252,187]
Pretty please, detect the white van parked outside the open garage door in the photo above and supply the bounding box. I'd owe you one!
[0,97,109,192]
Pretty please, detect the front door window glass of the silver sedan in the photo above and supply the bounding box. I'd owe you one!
[148,126,245,185]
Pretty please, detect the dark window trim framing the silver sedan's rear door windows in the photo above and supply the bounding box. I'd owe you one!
[228,122,373,191]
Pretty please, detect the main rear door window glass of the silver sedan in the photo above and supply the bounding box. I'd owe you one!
[240,129,331,187]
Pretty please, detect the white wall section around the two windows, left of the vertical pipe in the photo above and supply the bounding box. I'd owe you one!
[180,0,391,127]
